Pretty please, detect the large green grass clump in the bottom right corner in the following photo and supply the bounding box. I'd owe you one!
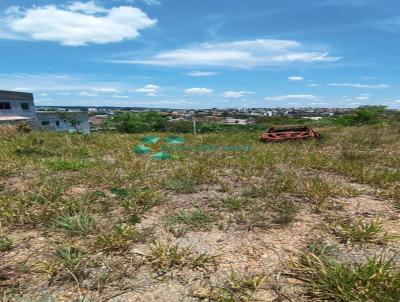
[297,252,400,302]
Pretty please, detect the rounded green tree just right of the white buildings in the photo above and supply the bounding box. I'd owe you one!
[103,112,166,133]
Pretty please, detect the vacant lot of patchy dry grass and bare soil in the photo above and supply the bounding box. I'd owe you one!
[0,126,400,302]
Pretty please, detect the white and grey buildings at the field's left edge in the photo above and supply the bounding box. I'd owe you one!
[0,90,90,134]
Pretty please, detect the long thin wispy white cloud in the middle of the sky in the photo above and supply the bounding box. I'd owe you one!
[113,39,341,68]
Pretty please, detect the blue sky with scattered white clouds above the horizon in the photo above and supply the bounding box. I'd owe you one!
[0,0,400,108]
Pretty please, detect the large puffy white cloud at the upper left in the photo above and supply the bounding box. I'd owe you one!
[0,1,157,46]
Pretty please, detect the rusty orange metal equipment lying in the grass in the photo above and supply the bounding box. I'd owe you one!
[261,126,320,143]
